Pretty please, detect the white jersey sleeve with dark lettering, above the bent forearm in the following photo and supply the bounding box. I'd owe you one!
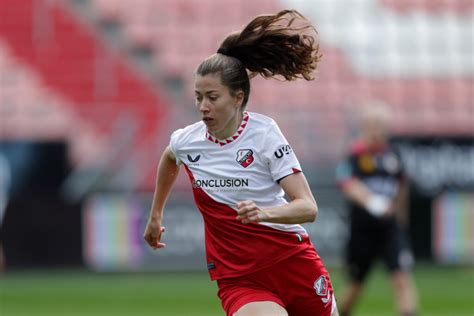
[263,121,301,182]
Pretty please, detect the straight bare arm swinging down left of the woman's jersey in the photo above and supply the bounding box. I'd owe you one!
[143,146,179,249]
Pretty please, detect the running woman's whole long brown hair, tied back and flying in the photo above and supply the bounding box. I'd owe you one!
[196,10,322,108]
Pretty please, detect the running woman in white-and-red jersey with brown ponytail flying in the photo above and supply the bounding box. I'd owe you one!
[144,10,337,316]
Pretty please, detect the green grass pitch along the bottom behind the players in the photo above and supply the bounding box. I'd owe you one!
[0,265,474,316]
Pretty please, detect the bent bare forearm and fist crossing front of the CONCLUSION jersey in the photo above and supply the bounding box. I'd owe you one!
[237,172,318,224]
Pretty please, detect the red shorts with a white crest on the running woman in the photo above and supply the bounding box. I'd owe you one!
[217,248,336,316]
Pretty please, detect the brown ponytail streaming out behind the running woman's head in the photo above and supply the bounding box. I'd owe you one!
[219,10,321,80]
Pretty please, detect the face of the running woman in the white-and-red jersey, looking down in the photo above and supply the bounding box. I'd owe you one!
[194,74,243,139]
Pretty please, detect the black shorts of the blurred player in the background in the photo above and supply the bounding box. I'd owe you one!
[346,220,413,282]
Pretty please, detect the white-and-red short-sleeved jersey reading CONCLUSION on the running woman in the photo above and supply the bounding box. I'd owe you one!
[170,112,307,279]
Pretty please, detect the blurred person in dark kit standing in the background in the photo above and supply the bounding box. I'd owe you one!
[337,102,417,316]
